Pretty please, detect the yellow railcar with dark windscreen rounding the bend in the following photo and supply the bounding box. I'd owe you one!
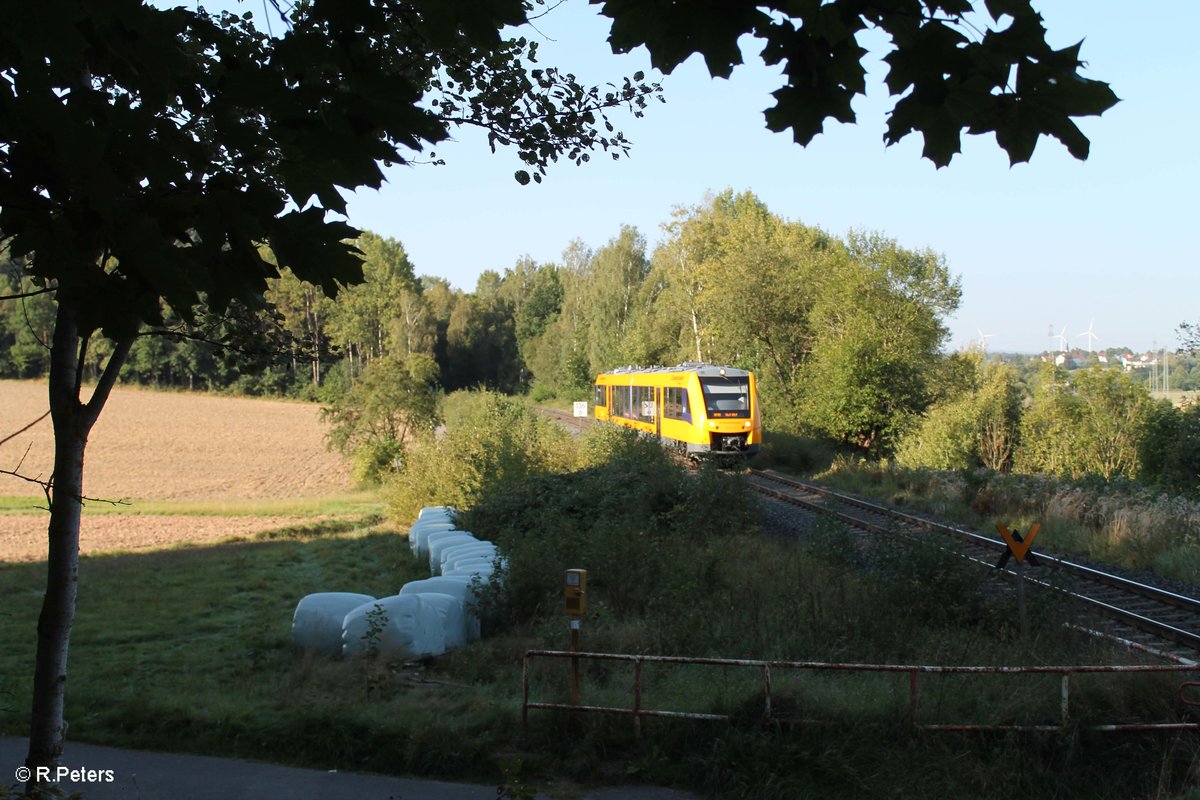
[593,362,762,458]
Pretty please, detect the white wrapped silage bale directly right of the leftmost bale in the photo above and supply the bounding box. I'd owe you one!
[342,594,457,660]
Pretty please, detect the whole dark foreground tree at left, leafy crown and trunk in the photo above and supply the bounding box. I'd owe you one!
[0,0,653,782]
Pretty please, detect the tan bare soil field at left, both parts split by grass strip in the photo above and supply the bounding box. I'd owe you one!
[0,380,350,561]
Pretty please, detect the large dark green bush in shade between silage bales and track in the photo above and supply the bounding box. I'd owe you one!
[466,426,754,624]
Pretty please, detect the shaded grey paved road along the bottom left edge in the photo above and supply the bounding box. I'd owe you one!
[0,738,697,800]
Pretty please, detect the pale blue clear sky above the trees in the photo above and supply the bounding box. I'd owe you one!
[220,0,1200,351]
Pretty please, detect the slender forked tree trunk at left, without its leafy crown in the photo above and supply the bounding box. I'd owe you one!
[25,306,132,793]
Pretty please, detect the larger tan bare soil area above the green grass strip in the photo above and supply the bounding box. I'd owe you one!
[0,380,350,500]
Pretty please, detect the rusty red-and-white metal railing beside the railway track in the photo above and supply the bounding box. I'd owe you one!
[521,650,1200,734]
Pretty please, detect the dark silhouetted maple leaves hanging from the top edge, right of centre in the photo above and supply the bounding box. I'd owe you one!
[593,0,1117,167]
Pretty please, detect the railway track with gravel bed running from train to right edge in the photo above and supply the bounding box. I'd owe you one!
[746,470,1200,663]
